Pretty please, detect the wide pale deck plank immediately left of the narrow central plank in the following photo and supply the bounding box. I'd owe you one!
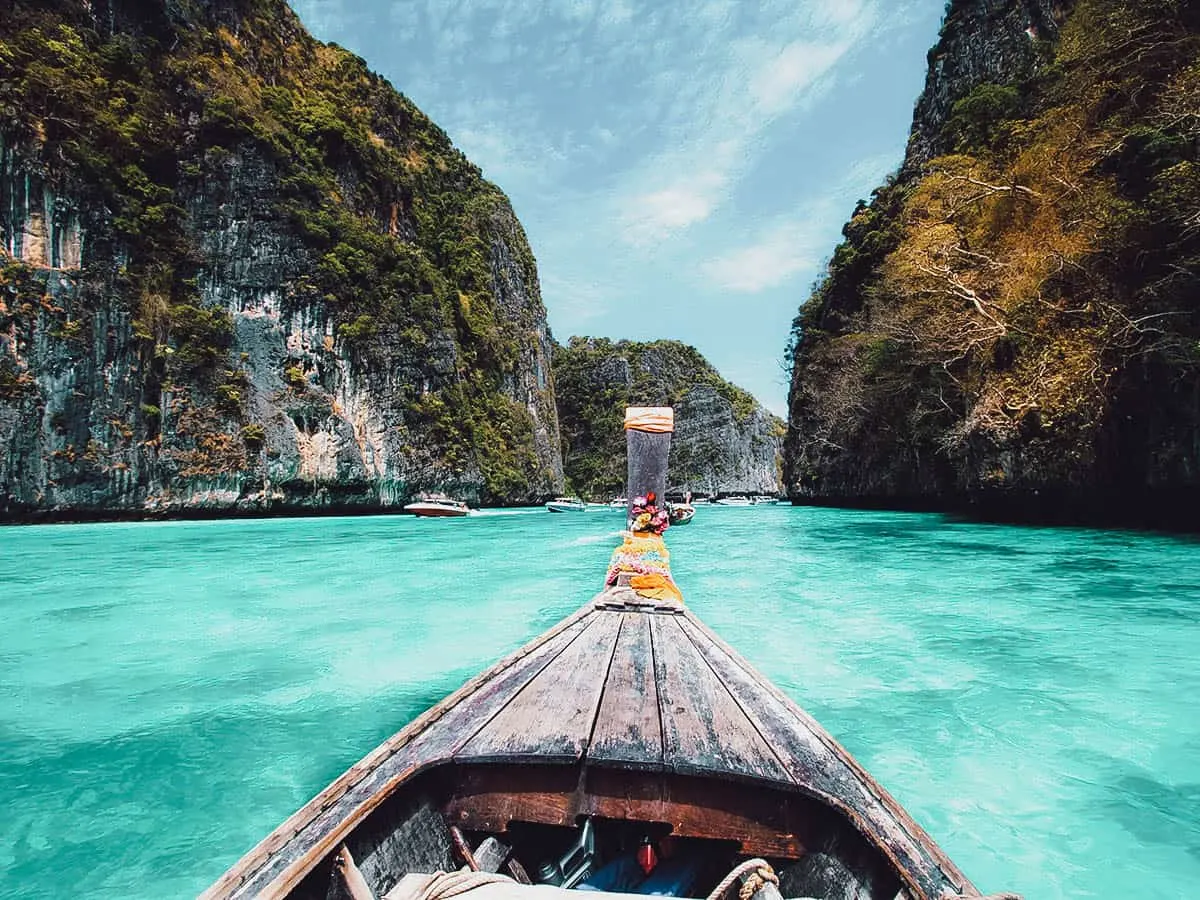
[455,612,622,762]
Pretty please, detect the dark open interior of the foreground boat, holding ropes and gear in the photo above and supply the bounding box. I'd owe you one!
[300,764,912,900]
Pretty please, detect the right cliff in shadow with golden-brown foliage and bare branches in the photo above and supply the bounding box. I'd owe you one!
[785,0,1200,528]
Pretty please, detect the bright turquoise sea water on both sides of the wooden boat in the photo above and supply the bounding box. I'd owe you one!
[0,506,1200,900]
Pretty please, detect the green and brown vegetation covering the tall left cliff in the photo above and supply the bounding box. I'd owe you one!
[0,0,557,513]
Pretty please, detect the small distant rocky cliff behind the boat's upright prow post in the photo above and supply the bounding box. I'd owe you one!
[554,337,784,500]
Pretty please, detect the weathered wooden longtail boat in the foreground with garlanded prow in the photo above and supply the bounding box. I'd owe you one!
[203,410,1012,900]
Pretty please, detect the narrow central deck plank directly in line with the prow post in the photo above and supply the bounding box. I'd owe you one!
[588,612,662,769]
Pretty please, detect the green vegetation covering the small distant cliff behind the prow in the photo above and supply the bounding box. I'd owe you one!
[554,337,781,499]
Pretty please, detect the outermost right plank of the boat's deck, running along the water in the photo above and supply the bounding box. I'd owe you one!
[677,614,973,898]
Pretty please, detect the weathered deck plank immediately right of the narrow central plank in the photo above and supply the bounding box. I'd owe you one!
[649,616,792,785]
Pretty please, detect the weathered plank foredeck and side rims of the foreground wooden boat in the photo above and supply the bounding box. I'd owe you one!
[206,588,978,900]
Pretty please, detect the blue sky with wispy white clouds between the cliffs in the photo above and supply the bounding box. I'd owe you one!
[292,0,946,415]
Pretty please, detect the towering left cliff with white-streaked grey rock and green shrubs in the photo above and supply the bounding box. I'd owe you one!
[0,0,563,518]
